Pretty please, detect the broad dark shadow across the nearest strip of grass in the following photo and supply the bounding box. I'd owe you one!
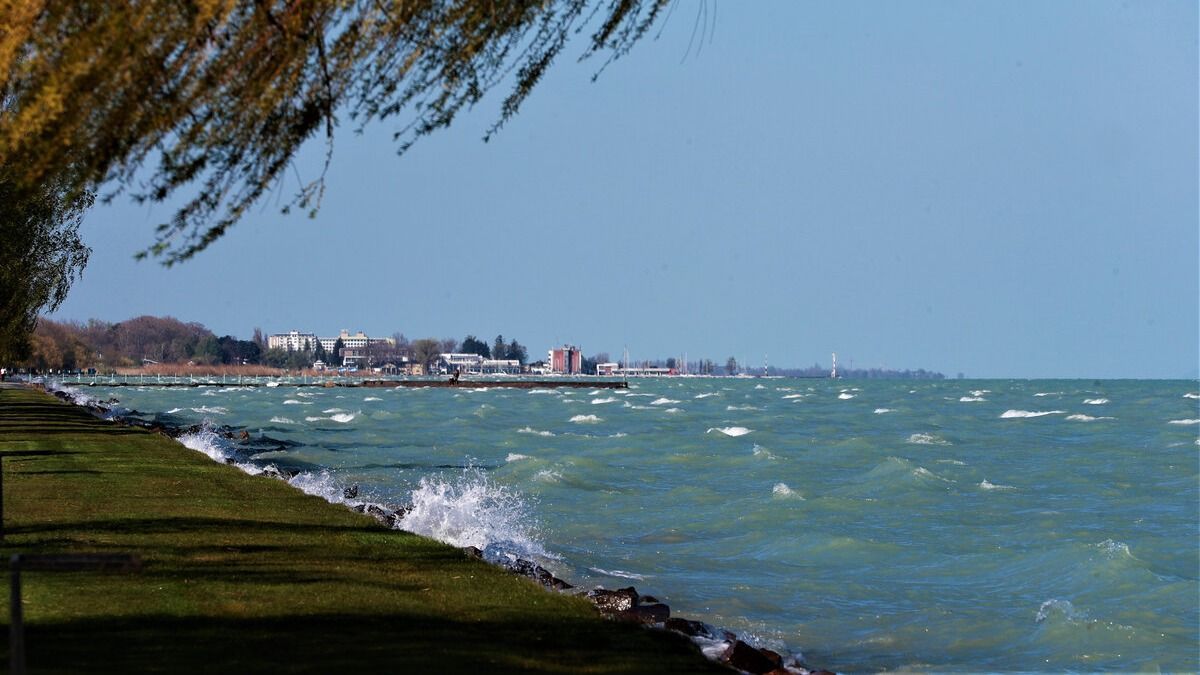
[0,610,727,674]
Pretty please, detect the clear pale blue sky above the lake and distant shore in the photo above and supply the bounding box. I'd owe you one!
[52,0,1200,378]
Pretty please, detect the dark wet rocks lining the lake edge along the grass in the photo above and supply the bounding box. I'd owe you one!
[42,387,833,675]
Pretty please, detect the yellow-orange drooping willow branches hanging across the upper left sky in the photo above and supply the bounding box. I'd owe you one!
[0,0,670,264]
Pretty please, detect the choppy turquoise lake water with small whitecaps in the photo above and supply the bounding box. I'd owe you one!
[60,378,1200,671]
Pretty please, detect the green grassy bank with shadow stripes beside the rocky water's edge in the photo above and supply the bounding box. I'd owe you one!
[0,389,725,673]
